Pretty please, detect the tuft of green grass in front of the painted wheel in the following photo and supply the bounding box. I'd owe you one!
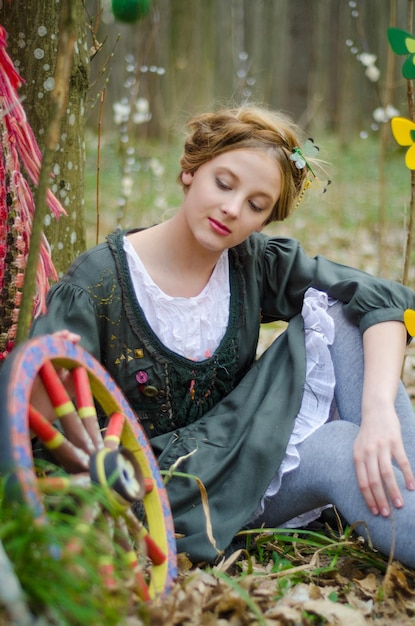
[0,482,135,626]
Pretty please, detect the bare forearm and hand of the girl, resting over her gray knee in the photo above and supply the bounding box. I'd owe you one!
[354,321,415,516]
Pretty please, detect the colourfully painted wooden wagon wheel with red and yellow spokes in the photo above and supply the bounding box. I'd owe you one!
[0,335,176,600]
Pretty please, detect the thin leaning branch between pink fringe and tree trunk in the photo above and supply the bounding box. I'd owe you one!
[16,0,76,345]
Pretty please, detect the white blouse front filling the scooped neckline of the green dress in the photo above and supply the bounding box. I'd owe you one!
[124,237,230,361]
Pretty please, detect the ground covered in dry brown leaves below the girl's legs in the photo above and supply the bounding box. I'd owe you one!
[139,538,415,626]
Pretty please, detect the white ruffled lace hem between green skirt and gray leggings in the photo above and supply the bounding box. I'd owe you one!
[258,288,335,528]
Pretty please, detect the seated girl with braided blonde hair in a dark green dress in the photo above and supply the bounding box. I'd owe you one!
[33,106,415,567]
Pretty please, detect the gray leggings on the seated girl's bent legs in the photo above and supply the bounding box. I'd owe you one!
[250,303,415,568]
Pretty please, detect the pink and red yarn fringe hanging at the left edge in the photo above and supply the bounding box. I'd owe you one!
[0,26,66,360]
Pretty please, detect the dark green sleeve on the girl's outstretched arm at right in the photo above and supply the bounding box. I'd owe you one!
[247,236,415,332]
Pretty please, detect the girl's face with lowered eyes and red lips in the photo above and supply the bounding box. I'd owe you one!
[182,148,282,252]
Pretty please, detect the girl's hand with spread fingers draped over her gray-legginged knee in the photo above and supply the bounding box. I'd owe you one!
[353,403,415,517]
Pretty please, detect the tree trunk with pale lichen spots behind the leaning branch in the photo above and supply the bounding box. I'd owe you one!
[0,0,89,274]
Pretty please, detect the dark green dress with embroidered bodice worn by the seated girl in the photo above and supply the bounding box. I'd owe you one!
[32,231,415,562]
